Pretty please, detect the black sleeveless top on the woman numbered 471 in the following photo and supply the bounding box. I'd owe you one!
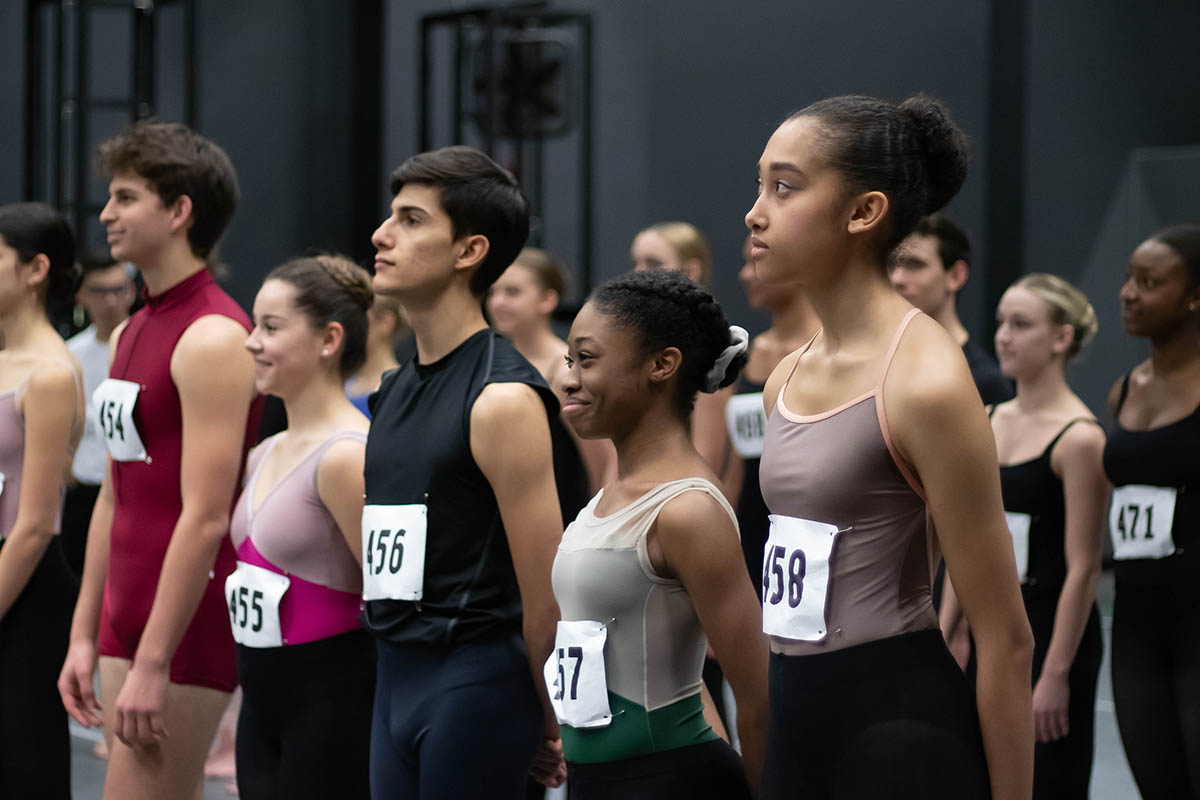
[1104,374,1200,589]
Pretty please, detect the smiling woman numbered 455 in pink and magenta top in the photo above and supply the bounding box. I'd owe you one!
[226,255,374,800]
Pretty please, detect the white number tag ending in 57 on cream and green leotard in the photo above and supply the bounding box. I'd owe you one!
[542,619,612,728]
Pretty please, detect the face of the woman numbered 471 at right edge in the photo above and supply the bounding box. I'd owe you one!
[1121,239,1200,339]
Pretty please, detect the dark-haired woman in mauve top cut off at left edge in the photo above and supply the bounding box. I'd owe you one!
[0,203,84,800]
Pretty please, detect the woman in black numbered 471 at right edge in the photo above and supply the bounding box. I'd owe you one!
[1104,223,1200,800]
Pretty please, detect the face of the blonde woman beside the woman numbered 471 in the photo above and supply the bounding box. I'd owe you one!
[996,285,1074,380]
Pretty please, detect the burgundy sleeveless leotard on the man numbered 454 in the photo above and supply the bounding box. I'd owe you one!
[98,270,263,692]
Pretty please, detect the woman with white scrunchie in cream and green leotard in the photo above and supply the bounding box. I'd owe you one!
[546,270,767,800]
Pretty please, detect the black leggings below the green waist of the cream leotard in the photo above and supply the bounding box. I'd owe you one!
[566,739,750,800]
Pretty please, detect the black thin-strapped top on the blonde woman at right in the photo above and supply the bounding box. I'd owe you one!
[989,415,1098,599]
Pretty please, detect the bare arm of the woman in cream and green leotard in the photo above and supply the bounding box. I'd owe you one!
[647,492,768,790]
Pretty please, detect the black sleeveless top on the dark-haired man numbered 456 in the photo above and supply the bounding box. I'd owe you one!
[362,329,558,644]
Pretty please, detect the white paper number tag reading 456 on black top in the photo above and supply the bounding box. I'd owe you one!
[362,503,427,600]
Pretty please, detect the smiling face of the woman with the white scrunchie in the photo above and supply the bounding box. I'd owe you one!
[563,302,649,439]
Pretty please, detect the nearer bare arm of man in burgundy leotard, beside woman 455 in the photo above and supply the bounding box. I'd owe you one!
[114,315,254,745]
